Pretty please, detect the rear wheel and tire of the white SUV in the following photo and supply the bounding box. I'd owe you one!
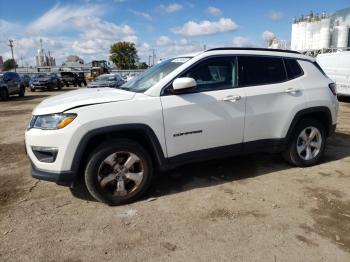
[283,118,327,167]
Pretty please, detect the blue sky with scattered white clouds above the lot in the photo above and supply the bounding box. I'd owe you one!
[0,0,350,66]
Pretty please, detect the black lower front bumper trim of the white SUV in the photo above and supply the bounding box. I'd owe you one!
[31,162,76,187]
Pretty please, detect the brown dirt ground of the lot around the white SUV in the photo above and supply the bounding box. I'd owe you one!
[0,88,350,262]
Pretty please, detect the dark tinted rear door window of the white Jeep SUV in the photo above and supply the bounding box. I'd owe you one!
[238,56,287,86]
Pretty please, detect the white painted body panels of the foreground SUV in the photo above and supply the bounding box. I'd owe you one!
[25,50,338,175]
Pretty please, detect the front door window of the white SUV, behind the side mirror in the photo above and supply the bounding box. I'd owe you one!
[181,57,237,92]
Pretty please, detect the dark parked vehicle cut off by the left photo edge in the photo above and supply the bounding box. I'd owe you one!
[0,72,26,101]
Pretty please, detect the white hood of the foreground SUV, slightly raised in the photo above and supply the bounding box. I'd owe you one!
[33,88,135,115]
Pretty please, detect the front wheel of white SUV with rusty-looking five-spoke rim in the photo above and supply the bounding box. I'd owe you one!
[85,139,153,205]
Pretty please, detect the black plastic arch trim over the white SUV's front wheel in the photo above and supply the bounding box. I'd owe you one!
[71,124,165,180]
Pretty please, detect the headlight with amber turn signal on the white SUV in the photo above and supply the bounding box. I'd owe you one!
[29,113,77,130]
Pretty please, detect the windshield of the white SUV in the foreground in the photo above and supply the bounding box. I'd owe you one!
[121,57,191,92]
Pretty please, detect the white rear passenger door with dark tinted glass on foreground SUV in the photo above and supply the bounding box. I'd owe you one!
[238,56,306,142]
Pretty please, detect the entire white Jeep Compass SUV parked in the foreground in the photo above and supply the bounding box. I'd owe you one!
[25,48,338,205]
